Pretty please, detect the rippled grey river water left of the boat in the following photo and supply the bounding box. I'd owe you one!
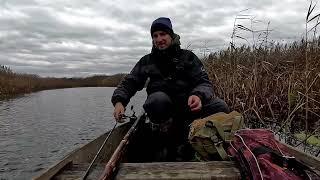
[0,88,146,180]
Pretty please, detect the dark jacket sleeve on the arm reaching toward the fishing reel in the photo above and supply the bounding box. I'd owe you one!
[111,58,147,106]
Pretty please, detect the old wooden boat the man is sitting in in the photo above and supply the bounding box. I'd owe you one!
[33,114,320,180]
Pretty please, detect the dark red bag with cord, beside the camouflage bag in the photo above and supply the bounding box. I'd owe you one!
[228,129,320,180]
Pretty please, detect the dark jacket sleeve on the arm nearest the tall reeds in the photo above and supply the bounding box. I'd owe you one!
[189,52,213,103]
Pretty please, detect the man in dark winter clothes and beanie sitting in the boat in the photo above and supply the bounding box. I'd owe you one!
[111,17,229,160]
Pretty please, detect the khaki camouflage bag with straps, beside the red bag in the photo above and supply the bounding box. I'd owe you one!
[188,111,244,161]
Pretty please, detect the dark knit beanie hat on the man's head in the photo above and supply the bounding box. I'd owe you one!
[150,17,174,37]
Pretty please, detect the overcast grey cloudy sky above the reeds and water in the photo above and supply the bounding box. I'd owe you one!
[0,0,320,77]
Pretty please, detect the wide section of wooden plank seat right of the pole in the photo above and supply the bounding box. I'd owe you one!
[115,161,240,180]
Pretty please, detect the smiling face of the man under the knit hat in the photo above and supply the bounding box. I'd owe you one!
[152,31,172,50]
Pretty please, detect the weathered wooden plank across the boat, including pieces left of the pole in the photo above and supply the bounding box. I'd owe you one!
[54,161,240,180]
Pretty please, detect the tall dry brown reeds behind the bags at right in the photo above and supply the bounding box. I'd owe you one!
[204,39,320,131]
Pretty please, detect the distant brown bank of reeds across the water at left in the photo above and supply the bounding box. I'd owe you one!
[0,66,125,99]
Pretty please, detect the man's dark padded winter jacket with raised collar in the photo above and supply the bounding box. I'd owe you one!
[111,36,213,106]
